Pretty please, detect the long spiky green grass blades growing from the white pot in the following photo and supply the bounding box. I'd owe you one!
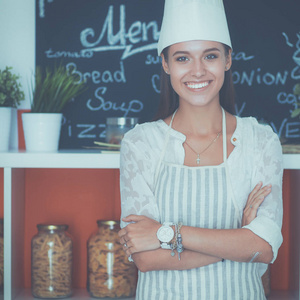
[31,65,85,113]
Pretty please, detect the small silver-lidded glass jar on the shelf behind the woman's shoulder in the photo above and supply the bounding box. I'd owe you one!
[106,118,138,145]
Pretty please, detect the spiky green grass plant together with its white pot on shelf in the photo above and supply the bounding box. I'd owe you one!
[22,65,85,152]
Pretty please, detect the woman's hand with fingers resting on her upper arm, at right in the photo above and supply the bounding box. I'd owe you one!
[242,182,272,226]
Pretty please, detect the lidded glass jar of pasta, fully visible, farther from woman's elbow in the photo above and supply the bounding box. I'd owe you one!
[31,224,73,299]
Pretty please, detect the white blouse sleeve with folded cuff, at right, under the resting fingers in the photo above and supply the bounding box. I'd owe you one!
[243,129,283,263]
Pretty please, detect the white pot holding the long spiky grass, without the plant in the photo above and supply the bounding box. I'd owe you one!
[22,113,62,152]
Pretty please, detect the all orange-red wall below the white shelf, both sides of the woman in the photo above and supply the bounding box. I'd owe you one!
[0,169,299,290]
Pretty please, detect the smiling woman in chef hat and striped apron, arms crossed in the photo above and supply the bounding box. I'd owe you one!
[119,0,282,300]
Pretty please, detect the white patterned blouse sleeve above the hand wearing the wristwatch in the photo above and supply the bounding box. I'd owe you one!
[120,138,159,228]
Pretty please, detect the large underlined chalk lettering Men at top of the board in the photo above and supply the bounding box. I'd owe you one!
[80,5,159,60]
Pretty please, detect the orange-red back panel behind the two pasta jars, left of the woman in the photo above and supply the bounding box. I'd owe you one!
[24,169,120,288]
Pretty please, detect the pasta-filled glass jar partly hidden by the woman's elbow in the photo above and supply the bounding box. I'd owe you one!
[87,220,137,298]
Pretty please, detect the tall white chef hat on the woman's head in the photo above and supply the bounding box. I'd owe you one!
[157,0,232,55]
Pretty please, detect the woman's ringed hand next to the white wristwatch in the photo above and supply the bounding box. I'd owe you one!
[119,215,161,256]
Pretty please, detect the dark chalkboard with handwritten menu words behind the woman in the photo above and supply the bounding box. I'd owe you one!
[36,0,300,149]
